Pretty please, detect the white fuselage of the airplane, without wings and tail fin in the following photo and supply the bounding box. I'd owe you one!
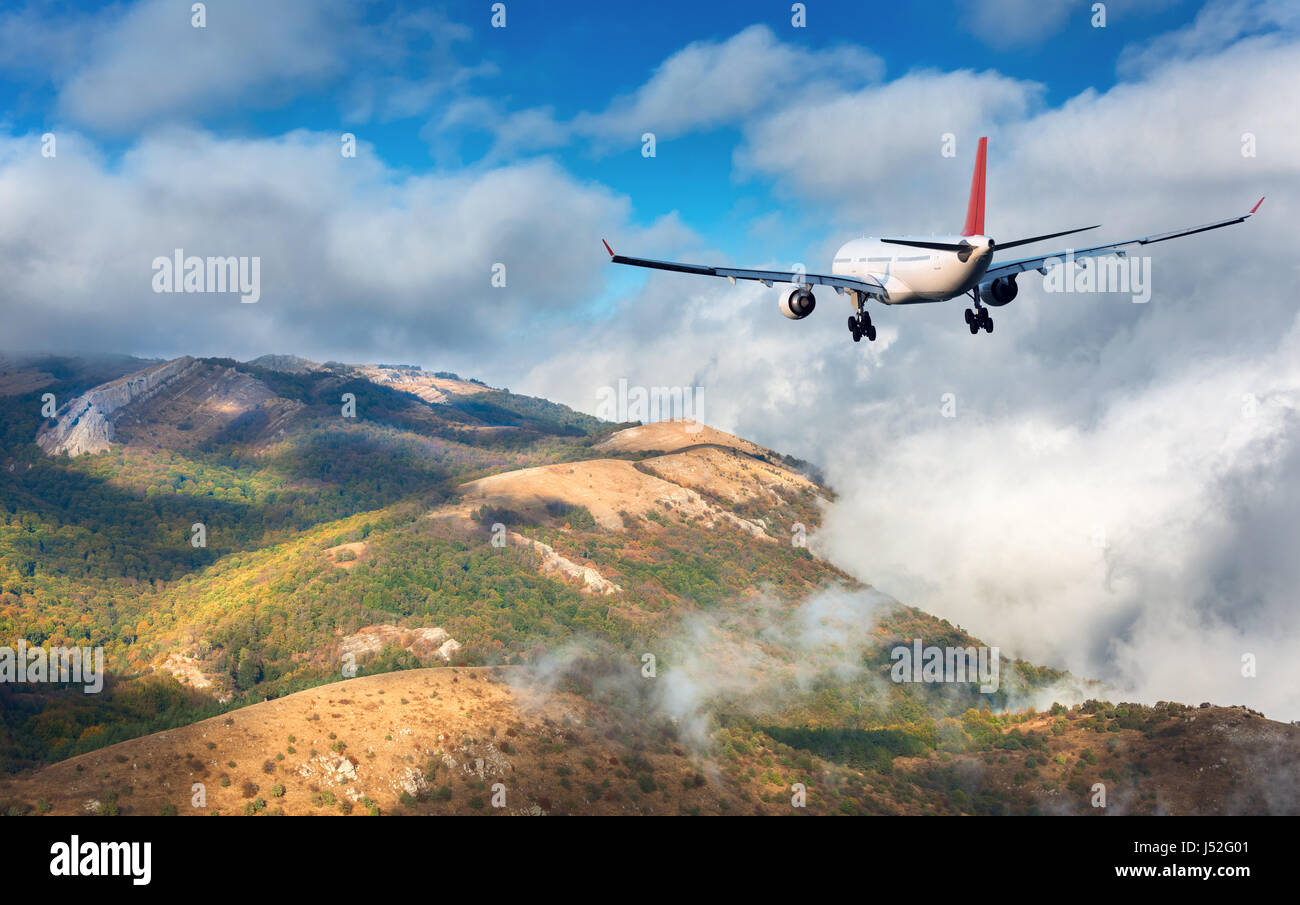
[831,235,993,304]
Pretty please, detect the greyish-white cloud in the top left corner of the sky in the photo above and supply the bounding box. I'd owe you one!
[0,0,495,135]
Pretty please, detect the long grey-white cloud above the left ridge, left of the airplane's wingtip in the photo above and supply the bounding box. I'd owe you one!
[0,130,683,364]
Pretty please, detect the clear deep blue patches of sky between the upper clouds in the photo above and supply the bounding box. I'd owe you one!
[0,0,1216,266]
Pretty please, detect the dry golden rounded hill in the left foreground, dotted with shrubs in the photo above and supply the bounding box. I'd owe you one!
[0,667,820,815]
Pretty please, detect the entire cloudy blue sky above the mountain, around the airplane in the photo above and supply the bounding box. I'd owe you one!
[0,0,1300,719]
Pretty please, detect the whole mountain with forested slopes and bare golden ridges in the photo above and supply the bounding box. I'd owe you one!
[0,355,1300,814]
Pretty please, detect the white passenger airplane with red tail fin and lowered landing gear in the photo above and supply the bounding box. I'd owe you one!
[601,138,1264,342]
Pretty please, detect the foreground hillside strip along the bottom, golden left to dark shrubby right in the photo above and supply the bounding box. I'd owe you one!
[0,667,1300,815]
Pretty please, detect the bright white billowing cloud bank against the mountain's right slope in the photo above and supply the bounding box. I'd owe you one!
[816,325,1300,718]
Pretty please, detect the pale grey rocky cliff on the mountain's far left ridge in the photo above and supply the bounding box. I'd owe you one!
[36,355,202,456]
